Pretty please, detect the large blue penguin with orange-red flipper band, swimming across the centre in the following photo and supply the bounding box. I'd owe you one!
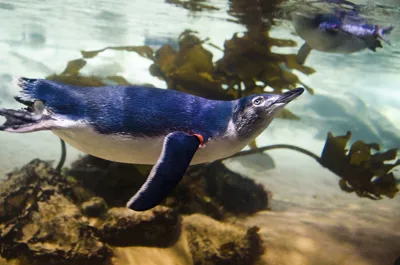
[0,78,304,211]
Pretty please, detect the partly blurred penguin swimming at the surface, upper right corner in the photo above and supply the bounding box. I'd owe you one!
[292,12,393,64]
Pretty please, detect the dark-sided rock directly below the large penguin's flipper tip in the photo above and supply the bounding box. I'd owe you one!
[98,206,180,247]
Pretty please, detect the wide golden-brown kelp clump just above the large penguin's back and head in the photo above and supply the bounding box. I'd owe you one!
[150,30,314,103]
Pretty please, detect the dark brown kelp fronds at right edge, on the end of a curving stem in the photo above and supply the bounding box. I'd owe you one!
[320,132,400,199]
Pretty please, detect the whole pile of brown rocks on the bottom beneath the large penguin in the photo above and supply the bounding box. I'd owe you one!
[0,156,268,265]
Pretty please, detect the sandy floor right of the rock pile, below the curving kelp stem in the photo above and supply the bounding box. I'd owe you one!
[227,146,400,265]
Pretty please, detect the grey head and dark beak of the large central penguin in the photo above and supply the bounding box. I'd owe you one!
[232,88,304,139]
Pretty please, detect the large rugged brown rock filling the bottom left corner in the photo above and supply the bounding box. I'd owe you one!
[0,160,111,265]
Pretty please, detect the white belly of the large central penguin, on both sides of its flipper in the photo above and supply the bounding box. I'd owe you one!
[52,126,246,165]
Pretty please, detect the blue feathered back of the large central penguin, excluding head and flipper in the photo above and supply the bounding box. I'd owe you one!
[19,78,234,139]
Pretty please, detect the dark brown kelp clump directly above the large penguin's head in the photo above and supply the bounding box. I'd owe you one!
[216,32,315,95]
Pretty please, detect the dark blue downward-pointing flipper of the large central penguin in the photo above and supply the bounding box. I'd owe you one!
[126,132,201,211]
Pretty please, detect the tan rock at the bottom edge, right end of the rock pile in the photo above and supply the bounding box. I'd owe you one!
[183,214,264,265]
